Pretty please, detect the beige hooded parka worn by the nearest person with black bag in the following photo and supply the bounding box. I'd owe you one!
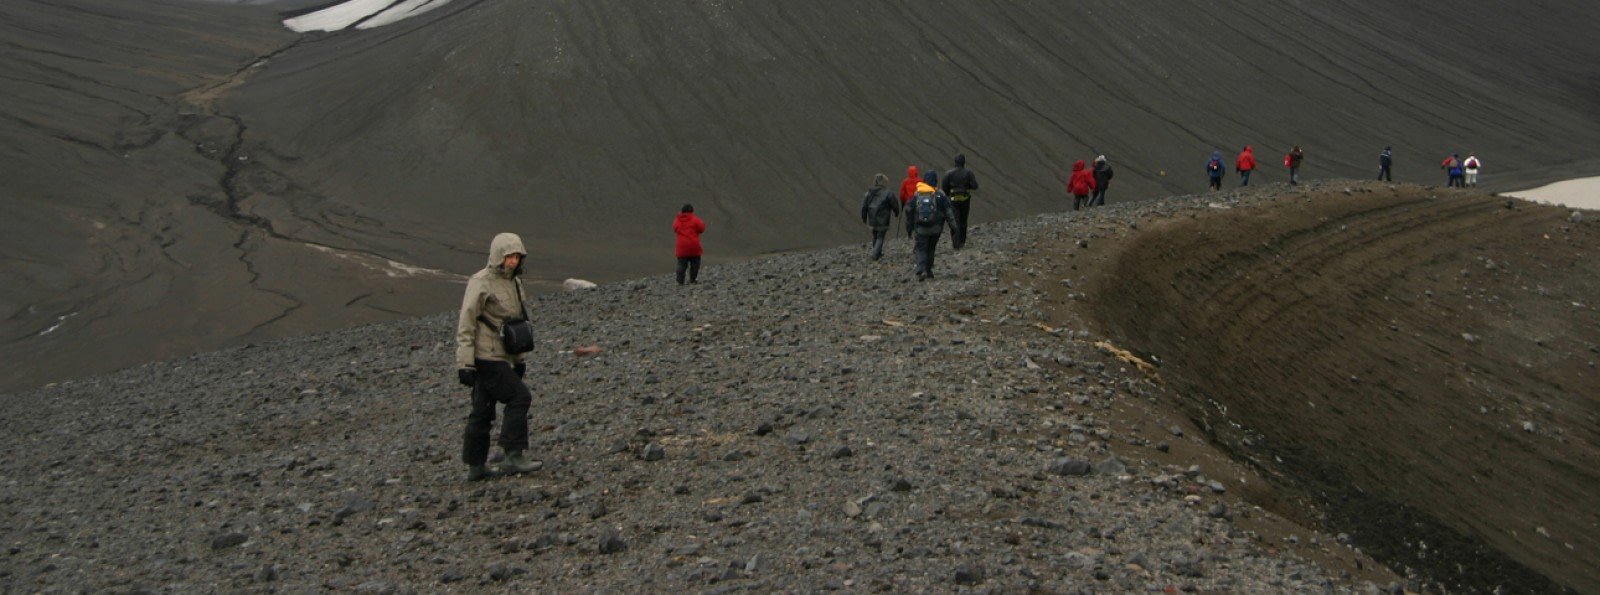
[456,234,528,368]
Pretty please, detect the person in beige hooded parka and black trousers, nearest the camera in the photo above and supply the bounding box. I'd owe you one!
[456,234,542,481]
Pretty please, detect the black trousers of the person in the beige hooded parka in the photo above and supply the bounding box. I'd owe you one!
[461,360,533,465]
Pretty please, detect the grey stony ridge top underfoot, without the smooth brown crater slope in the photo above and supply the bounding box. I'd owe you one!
[0,182,1595,593]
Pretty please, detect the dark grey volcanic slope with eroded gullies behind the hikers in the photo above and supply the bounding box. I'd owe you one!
[0,0,1600,389]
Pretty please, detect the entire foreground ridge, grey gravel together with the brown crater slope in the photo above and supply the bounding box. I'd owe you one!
[0,182,1600,592]
